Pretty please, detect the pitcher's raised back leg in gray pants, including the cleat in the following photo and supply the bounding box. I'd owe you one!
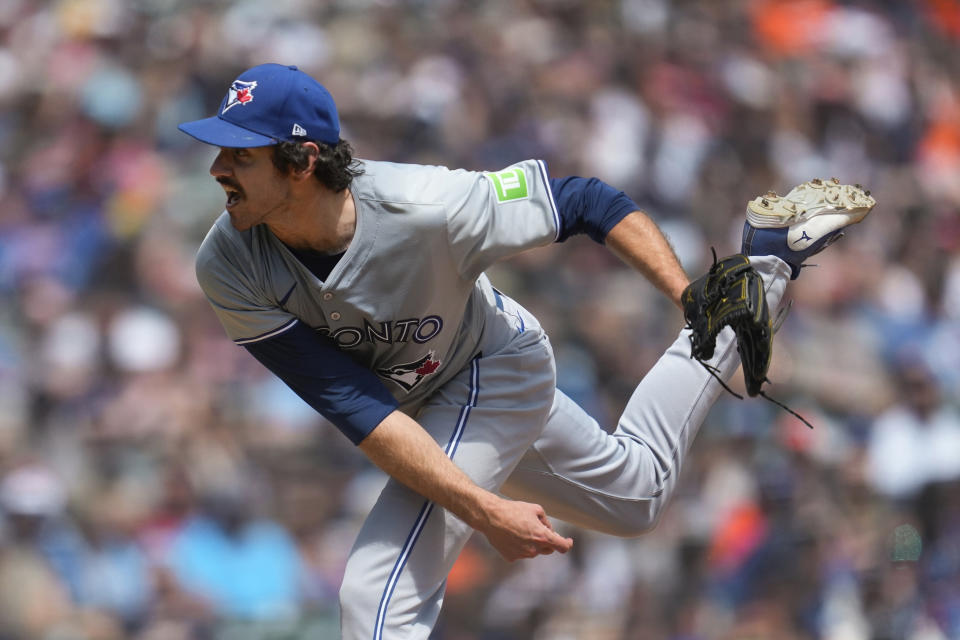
[502,180,875,536]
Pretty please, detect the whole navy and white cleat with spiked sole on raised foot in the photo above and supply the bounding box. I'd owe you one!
[741,178,877,279]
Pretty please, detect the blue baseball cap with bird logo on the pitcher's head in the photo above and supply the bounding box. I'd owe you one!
[178,63,340,147]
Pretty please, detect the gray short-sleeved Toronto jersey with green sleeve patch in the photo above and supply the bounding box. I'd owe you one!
[197,160,559,410]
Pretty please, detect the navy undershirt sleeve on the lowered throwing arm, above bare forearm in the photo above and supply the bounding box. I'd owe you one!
[243,322,397,444]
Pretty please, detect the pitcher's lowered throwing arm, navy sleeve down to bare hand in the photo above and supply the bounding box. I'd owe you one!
[244,324,573,561]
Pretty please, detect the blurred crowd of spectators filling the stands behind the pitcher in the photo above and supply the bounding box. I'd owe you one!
[0,0,960,640]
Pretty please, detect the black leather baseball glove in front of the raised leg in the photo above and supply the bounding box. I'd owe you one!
[682,253,773,396]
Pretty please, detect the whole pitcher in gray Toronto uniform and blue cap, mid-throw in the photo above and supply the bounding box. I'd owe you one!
[180,64,874,640]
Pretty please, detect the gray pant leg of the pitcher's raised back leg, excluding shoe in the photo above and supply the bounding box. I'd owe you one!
[502,257,790,536]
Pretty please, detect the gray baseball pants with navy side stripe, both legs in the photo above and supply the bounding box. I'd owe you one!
[340,256,790,640]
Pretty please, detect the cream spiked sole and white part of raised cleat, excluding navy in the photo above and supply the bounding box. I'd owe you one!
[747,178,877,251]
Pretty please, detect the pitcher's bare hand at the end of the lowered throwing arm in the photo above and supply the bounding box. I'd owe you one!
[478,499,573,562]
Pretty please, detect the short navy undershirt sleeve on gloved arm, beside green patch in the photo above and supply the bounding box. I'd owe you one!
[550,176,640,244]
